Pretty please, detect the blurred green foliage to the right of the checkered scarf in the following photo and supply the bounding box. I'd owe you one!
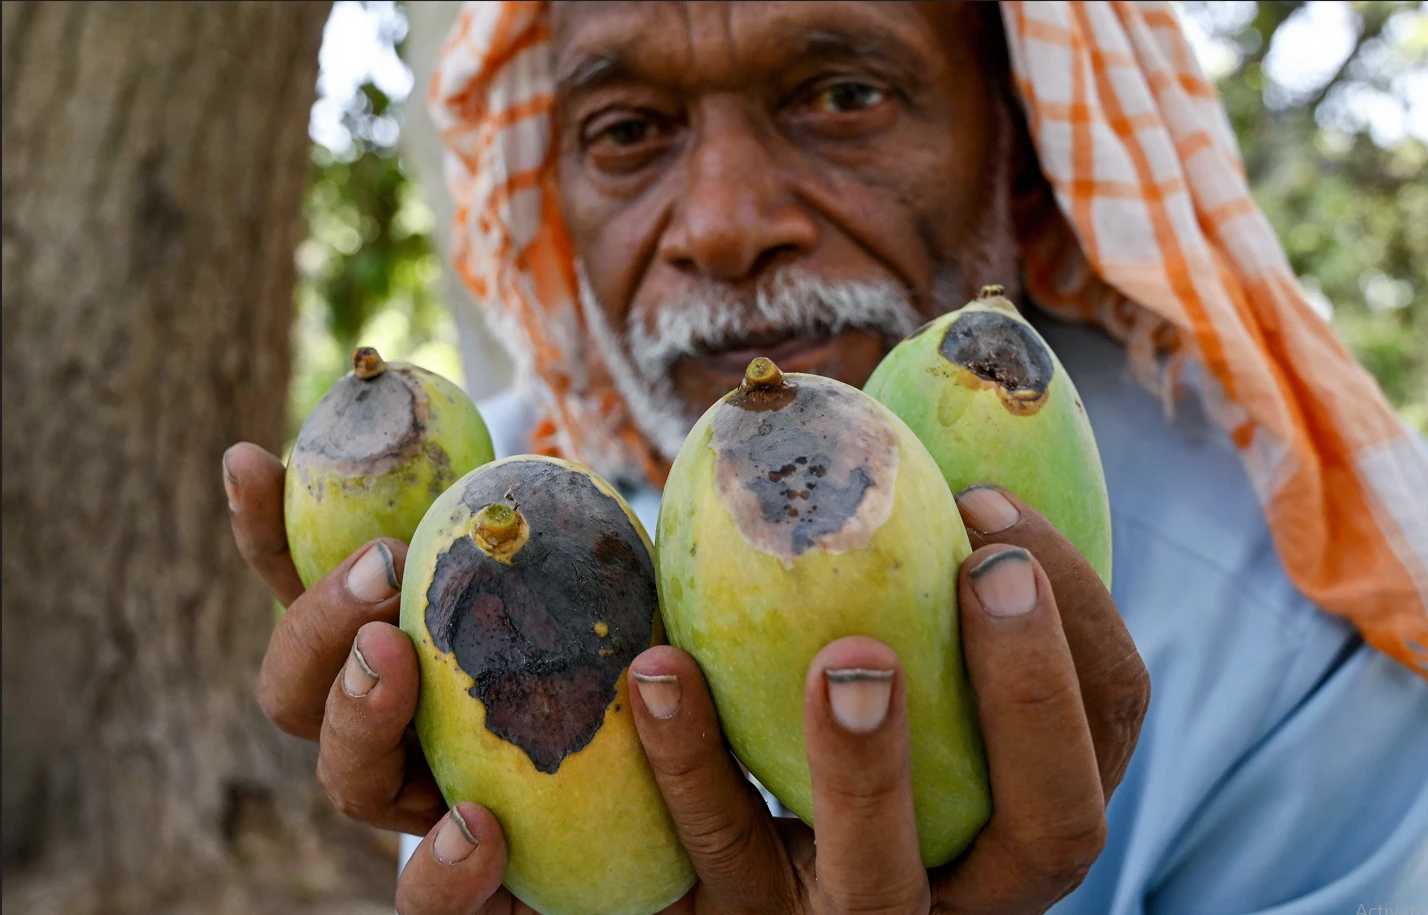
[1184,1,1428,433]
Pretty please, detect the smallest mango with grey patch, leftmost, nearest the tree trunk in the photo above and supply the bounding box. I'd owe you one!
[283,347,496,588]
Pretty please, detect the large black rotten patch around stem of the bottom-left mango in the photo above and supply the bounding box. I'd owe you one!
[426,461,658,772]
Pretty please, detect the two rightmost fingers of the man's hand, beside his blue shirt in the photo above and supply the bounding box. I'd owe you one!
[932,487,1151,914]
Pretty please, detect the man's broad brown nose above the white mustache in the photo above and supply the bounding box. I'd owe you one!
[660,118,818,283]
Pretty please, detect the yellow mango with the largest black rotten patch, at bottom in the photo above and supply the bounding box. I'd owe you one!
[401,455,694,915]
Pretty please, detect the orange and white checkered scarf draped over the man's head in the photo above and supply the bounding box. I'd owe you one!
[428,1,1428,677]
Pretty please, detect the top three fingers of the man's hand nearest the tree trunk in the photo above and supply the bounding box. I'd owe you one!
[223,443,446,835]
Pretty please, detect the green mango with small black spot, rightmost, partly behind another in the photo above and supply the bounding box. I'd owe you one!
[863,285,1111,587]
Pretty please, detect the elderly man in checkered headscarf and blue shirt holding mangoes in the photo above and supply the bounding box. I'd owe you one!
[226,3,1428,915]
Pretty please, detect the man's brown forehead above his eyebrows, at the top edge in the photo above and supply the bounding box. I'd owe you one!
[551,1,962,92]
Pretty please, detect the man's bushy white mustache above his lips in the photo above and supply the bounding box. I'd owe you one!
[625,268,921,383]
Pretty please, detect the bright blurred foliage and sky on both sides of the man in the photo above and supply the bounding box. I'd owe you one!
[288,1,1428,437]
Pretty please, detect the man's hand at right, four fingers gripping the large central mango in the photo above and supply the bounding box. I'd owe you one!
[619,487,1150,915]
